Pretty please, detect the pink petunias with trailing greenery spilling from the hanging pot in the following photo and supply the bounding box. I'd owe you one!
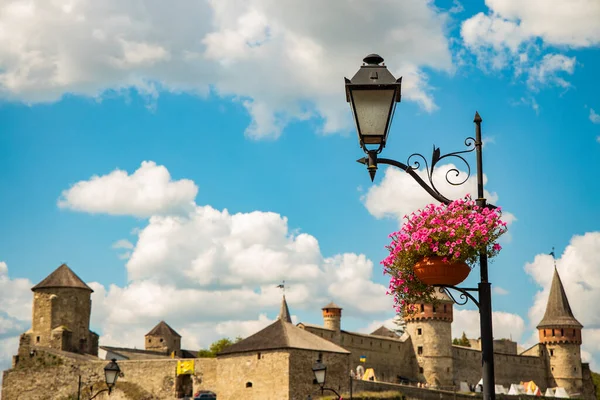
[381,196,507,313]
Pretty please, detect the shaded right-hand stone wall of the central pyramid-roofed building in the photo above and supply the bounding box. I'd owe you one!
[288,349,350,400]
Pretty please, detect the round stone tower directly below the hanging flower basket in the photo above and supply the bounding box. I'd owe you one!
[404,289,454,387]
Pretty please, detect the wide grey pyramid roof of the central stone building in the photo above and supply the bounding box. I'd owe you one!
[217,319,350,356]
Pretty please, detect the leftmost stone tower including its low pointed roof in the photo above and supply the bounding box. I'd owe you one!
[21,264,98,355]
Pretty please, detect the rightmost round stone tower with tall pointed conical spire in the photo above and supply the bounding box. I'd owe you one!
[537,267,583,394]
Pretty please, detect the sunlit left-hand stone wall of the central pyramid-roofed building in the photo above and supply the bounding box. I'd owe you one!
[216,350,290,400]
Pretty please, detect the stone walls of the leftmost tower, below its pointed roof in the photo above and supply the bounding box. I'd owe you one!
[31,288,93,354]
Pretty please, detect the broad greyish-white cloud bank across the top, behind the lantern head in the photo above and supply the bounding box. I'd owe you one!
[0,0,451,138]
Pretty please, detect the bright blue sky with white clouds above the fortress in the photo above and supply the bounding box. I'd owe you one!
[0,0,600,378]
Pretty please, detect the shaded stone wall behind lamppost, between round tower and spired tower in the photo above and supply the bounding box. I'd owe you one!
[452,346,548,390]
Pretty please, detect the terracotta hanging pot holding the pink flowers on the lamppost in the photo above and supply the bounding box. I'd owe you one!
[413,256,471,286]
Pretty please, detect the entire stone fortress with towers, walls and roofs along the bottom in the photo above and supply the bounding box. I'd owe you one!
[2,265,595,400]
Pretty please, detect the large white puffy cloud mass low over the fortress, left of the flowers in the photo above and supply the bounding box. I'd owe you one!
[55,162,393,348]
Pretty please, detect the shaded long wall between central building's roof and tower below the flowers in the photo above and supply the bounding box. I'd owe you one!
[301,325,417,382]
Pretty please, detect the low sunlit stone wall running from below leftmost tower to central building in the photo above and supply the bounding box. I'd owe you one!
[2,348,217,400]
